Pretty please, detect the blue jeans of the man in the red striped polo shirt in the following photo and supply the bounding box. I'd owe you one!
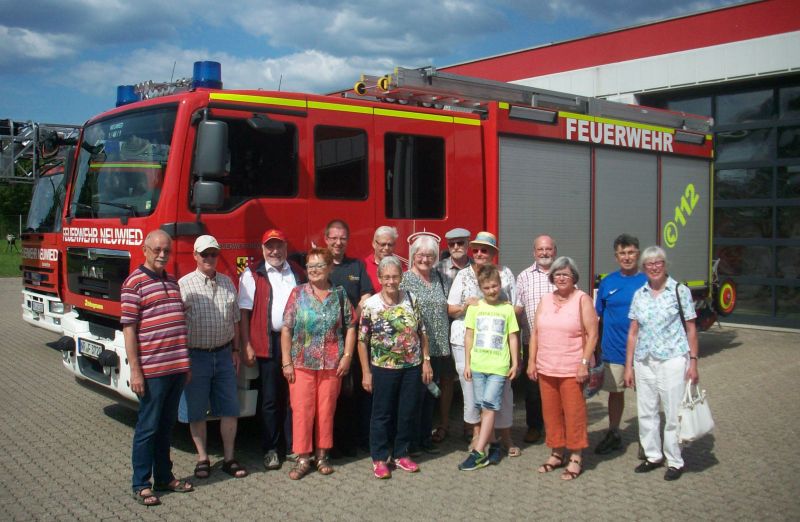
[131,373,186,491]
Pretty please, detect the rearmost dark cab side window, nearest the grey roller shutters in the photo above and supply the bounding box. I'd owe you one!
[384,134,445,219]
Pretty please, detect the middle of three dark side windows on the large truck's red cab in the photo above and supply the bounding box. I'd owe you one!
[314,126,369,200]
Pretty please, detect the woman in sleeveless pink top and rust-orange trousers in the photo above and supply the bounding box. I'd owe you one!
[527,256,597,480]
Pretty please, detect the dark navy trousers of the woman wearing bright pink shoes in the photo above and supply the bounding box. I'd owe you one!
[369,365,422,460]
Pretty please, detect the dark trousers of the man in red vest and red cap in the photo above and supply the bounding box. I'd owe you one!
[256,332,292,454]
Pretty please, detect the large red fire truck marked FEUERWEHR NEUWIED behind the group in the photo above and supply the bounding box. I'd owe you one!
[54,62,713,415]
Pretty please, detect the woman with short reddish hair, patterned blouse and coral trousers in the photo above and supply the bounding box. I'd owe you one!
[281,248,356,480]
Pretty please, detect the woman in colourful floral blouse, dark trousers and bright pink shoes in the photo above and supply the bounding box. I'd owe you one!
[358,256,433,479]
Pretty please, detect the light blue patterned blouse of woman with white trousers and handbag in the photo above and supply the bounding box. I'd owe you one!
[628,277,697,361]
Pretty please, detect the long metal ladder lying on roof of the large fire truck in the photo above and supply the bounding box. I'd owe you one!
[345,67,713,134]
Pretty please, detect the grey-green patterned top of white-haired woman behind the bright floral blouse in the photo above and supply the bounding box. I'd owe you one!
[400,270,450,357]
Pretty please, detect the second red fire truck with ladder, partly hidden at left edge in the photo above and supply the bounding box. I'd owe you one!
[0,120,80,333]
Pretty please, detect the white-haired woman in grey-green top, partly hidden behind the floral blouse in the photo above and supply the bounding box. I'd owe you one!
[400,235,450,453]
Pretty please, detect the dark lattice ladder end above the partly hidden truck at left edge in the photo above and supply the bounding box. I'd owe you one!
[0,119,80,183]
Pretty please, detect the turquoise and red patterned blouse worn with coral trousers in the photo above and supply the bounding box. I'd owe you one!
[283,283,355,370]
